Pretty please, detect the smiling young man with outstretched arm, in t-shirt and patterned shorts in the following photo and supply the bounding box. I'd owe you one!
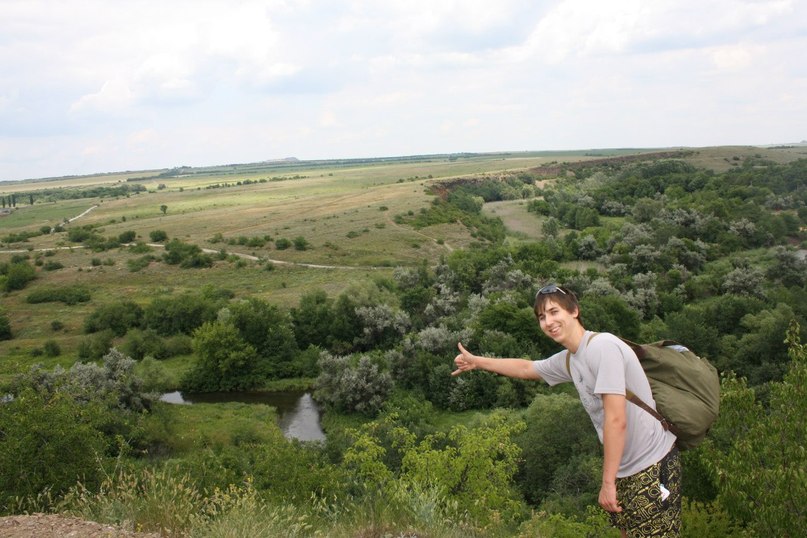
[452,284,681,538]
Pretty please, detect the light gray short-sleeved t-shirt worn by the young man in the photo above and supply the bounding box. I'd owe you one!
[533,331,675,478]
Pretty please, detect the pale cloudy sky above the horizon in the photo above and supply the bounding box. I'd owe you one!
[0,0,807,180]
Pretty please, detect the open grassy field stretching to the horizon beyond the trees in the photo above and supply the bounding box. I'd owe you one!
[0,146,807,377]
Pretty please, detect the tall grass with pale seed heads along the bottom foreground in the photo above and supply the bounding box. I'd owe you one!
[47,467,502,538]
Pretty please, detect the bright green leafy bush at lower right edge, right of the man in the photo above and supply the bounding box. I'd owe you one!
[702,323,807,537]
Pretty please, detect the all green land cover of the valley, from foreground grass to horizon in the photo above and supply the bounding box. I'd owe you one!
[0,144,807,536]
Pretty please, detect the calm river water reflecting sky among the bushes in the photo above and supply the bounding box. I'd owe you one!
[160,391,325,441]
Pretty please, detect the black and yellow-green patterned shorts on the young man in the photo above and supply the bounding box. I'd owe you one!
[609,447,681,538]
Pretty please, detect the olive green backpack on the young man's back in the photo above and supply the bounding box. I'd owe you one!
[566,333,720,450]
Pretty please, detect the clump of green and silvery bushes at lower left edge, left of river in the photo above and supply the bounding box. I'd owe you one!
[0,350,151,510]
